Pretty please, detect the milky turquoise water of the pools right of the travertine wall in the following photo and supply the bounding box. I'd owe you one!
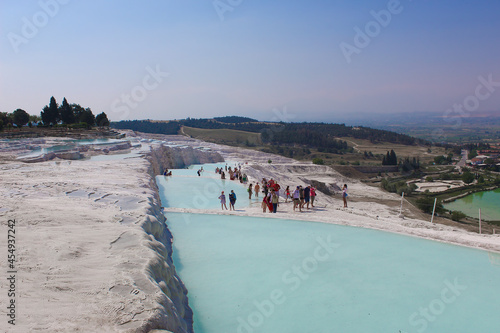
[157,164,500,333]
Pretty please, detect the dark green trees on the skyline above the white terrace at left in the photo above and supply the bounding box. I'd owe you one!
[0,96,110,130]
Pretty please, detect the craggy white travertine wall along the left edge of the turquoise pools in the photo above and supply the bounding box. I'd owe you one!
[137,145,224,333]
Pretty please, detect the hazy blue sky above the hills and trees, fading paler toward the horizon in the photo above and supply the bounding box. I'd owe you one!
[0,0,500,122]
